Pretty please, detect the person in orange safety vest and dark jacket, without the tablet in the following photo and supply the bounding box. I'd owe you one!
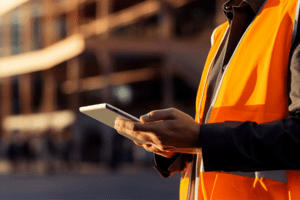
[115,0,300,200]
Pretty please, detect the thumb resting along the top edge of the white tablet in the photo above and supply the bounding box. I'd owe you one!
[140,108,176,123]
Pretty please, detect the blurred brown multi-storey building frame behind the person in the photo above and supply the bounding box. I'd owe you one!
[0,0,224,164]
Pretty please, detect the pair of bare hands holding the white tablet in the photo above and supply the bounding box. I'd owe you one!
[115,108,201,157]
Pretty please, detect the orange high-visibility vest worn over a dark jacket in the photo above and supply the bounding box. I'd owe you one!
[180,0,300,200]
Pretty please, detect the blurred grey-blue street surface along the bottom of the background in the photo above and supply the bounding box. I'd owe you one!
[0,161,180,200]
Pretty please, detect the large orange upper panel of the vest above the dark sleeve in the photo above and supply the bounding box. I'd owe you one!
[209,0,297,123]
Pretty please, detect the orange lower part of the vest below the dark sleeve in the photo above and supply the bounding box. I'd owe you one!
[198,172,288,200]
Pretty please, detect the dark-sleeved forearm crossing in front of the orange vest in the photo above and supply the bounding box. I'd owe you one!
[200,112,300,172]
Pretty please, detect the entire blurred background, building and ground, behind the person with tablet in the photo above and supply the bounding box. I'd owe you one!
[0,0,226,199]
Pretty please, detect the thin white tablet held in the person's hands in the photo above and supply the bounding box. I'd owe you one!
[79,103,145,144]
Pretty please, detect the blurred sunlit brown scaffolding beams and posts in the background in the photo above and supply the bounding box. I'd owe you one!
[0,0,221,141]
